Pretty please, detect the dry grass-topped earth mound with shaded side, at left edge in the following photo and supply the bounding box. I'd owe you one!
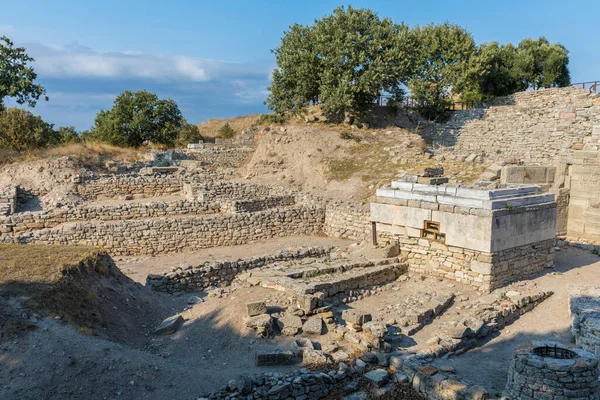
[0,244,109,336]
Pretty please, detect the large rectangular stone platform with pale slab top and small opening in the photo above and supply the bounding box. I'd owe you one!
[370,181,556,291]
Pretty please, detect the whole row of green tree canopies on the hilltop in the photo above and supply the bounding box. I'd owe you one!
[266,7,570,119]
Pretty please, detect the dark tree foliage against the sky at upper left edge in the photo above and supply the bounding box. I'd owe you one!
[0,36,48,110]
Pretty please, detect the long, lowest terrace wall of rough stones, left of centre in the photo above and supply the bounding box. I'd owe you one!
[11,205,325,255]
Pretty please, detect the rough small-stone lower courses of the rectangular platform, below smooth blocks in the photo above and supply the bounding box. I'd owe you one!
[394,236,554,292]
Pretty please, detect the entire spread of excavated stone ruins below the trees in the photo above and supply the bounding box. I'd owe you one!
[5,88,600,400]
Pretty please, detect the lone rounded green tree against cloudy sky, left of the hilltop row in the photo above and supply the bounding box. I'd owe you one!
[91,90,185,147]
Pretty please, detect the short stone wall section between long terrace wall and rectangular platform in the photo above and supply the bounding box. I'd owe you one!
[323,202,371,242]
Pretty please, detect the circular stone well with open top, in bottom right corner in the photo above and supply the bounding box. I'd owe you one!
[506,341,598,400]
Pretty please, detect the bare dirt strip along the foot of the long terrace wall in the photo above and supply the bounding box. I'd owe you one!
[115,236,354,284]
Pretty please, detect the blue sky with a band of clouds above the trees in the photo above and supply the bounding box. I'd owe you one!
[0,0,600,129]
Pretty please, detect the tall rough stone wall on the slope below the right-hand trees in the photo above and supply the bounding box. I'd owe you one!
[421,88,600,165]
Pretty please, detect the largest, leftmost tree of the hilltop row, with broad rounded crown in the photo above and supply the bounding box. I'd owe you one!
[266,7,417,118]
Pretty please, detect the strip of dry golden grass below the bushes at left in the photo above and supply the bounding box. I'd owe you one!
[0,142,146,167]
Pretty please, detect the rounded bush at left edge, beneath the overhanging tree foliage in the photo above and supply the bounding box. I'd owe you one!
[0,107,60,151]
